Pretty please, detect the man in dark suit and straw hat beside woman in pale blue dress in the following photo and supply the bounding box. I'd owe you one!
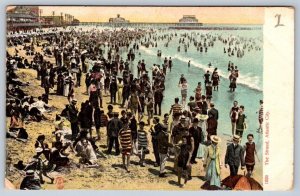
[225,135,245,176]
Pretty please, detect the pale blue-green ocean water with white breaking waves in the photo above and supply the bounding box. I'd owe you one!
[81,26,263,157]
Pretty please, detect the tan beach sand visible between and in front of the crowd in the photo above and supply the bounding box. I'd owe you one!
[6,41,262,190]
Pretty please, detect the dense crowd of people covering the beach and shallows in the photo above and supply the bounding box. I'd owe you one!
[6,28,263,189]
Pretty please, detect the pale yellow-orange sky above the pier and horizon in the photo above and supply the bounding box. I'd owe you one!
[7,6,264,24]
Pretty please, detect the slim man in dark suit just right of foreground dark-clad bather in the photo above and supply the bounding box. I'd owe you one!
[189,118,204,164]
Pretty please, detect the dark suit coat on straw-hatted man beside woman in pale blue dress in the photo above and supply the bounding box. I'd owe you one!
[225,143,245,167]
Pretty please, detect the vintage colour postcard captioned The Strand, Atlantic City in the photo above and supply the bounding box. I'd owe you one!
[5,5,294,191]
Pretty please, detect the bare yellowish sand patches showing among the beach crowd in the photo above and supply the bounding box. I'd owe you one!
[6,32,262,190]
